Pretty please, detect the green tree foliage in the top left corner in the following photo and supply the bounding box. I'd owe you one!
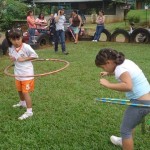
[0,0,28,30]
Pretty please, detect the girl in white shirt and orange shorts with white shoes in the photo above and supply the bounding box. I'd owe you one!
[6,28,38,120]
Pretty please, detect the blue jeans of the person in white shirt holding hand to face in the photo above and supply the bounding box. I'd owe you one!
[55,30,66,52]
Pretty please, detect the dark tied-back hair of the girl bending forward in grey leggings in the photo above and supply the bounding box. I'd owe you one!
[95,48,125,67]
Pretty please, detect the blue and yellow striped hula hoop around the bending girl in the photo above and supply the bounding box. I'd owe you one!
[96,98,150,108]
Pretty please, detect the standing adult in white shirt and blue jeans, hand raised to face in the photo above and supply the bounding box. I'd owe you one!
[54,8,69,55]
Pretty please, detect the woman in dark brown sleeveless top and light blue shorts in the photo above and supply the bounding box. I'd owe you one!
[70,10,82,44]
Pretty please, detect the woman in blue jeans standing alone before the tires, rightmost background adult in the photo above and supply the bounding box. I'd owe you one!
[92,10,105,42]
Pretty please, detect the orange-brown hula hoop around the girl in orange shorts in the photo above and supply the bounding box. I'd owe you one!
[4,58,69,78]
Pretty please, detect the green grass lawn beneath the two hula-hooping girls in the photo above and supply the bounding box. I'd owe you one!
[0,42,150,150]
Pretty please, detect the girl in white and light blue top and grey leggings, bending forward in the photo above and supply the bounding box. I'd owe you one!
[95,48,150,150]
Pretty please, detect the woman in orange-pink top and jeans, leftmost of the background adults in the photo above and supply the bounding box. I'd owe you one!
[27,10,36,44]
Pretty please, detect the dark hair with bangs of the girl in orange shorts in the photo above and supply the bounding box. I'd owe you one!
[5,28,23,47]
